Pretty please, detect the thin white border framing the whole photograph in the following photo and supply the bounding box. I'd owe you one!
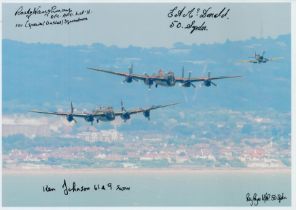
[0,0,296,210]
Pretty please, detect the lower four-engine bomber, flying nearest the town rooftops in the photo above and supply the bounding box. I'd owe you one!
[30,101,178,125]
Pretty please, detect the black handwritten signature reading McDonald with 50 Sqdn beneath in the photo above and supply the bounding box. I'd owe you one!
[167,6,230,34]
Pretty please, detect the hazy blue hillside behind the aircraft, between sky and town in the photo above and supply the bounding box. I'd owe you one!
[2,35,291,114]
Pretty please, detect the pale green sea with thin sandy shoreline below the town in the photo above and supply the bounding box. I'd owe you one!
[2,169,291,207]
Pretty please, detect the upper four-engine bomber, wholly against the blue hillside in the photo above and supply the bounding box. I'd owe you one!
[88,65,240,88]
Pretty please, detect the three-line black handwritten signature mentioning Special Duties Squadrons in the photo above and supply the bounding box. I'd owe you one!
[14,5,91,29]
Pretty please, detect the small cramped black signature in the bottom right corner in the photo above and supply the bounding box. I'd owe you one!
[246,193,287,206]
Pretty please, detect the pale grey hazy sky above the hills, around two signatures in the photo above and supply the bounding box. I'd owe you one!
[2,3,291,47]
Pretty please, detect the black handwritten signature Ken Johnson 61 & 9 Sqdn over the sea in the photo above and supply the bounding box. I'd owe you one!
[42,179,131,195]
